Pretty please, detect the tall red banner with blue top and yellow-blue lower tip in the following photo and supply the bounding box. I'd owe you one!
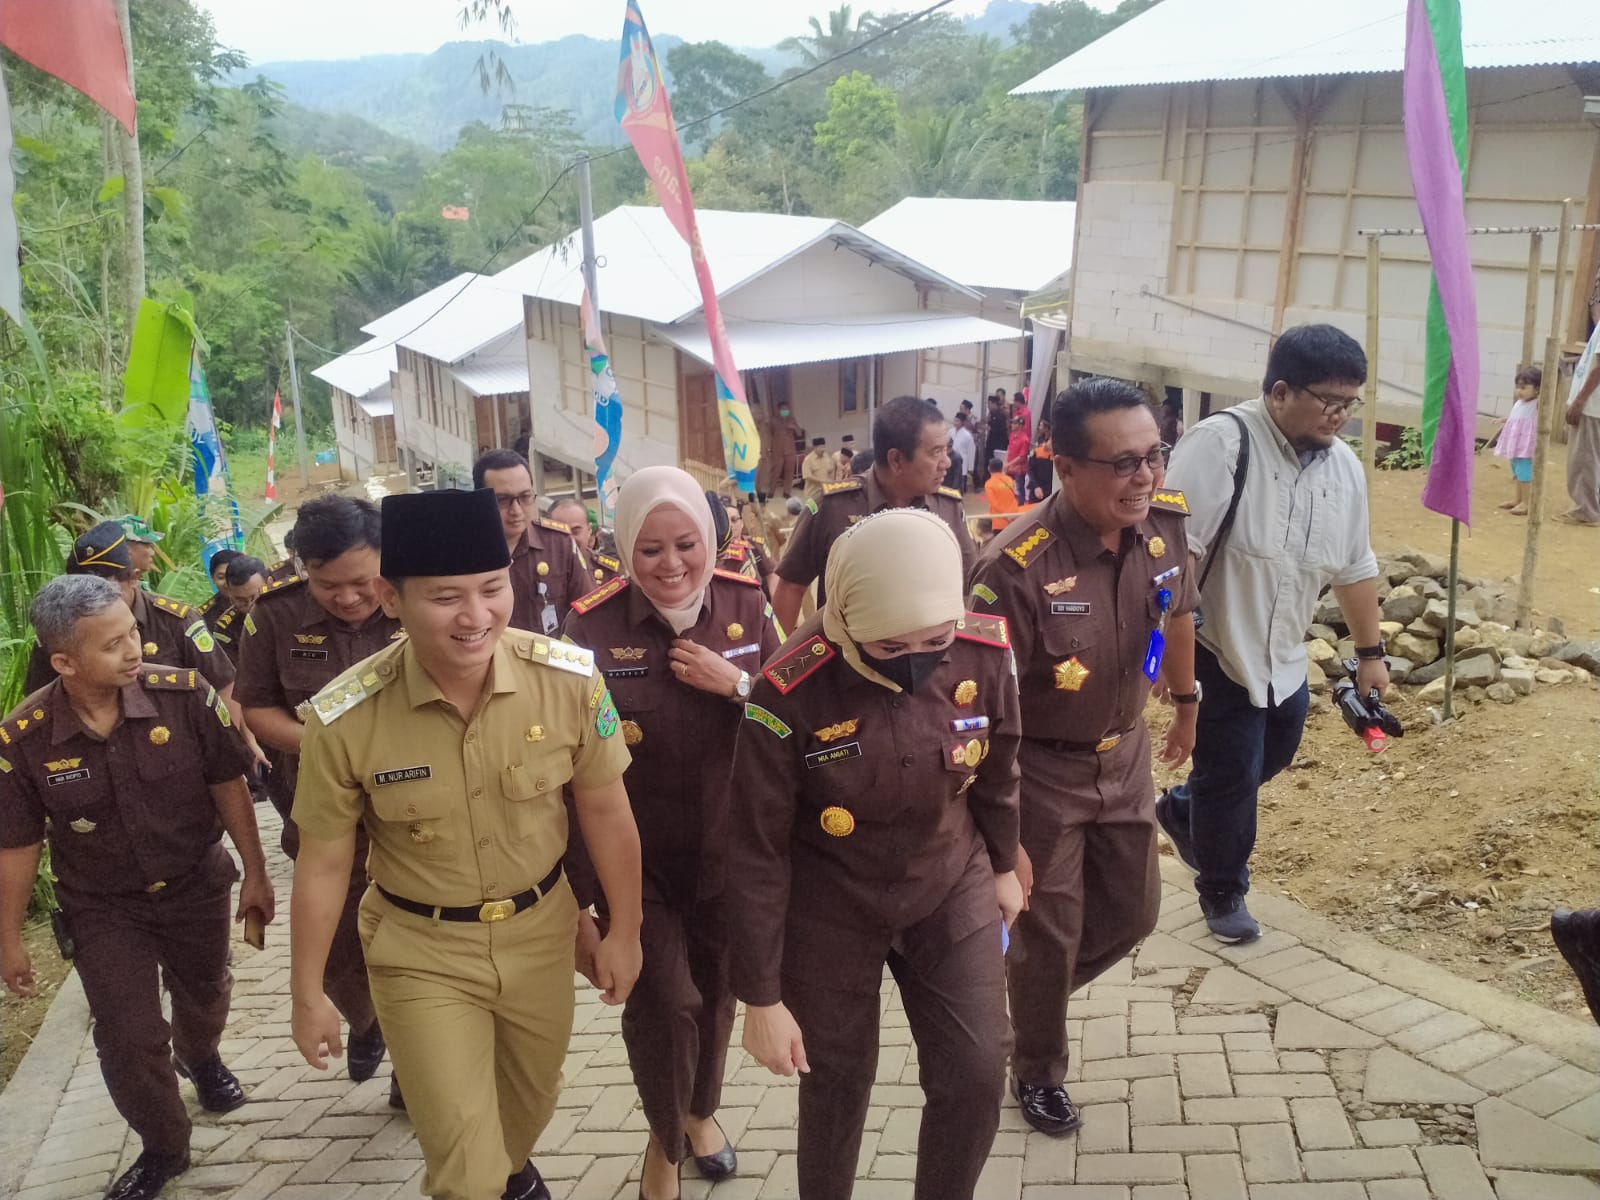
[616,0,762,493]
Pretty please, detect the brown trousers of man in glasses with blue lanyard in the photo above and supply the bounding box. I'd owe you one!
[1006,722,1162,1086]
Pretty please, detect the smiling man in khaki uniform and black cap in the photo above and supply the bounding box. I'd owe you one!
[291,490,640,1200]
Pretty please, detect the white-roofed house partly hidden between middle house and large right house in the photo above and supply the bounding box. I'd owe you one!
[861,195,1077,395]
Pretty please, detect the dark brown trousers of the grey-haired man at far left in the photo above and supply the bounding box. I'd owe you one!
[61,845,235,1155]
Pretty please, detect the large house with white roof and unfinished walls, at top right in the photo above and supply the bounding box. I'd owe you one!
[1014,0,1600,424]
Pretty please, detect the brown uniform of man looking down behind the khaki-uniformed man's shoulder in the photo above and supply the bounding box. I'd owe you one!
[233,574,402,1034]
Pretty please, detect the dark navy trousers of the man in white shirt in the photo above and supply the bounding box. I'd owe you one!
[1171,645,1310,910]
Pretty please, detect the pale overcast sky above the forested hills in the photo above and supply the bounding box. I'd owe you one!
[198,0,1115,62]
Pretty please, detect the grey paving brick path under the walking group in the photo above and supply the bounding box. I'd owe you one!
[9,810,1600,1200]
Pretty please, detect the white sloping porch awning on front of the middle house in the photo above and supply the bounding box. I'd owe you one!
[656,310,1022,371]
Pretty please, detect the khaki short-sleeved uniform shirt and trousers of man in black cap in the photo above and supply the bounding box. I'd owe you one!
[294,629,629,1200]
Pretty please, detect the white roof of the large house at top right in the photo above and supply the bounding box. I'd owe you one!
[1011,0,1600,94]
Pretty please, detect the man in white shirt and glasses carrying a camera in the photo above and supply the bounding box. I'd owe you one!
[1155,325,1389,942]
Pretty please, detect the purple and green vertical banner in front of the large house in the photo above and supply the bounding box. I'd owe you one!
[1402,0,1478,523]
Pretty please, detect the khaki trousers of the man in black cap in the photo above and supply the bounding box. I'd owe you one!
[360,878,578,1200]
